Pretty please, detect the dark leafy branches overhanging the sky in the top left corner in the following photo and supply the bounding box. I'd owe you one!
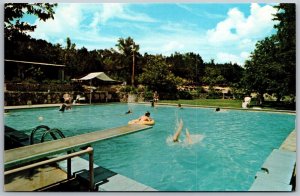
[4,3,57,39]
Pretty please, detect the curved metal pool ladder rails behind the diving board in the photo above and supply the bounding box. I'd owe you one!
[30,125,65,145]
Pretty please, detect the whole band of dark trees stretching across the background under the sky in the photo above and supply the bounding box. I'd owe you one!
[4,3,296,100]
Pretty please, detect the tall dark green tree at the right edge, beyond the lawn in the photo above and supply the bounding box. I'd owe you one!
[243,4,296,101]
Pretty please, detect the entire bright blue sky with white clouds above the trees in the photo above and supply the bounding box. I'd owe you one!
[24,3,276,66]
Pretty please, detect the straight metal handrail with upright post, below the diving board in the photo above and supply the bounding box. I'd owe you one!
[4,147,95,191]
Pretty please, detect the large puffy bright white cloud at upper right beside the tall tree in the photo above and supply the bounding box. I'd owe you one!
[207,3,276,45]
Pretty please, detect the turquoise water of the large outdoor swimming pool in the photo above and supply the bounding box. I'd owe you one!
[5,104,296,191]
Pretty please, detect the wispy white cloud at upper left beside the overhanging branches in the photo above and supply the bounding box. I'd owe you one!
[29,3,155,49]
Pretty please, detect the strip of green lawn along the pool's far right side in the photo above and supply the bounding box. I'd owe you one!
[159,99,296,111]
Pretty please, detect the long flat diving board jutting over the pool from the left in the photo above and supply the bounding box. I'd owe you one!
[4,124,152,169]
